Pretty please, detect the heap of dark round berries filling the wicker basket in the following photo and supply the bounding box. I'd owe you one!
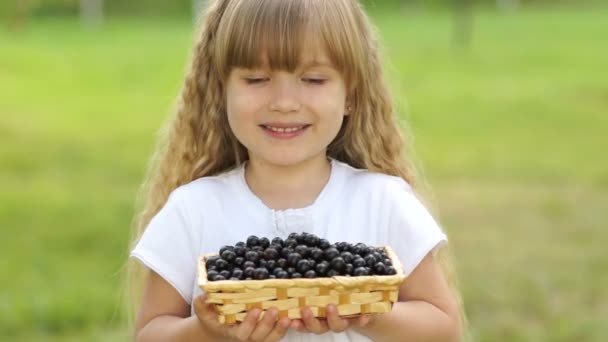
[206,233,397,281]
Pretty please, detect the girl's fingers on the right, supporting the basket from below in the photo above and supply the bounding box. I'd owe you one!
[290,304,372,335]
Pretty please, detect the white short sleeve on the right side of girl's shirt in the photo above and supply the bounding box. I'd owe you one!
[388,179,447,275]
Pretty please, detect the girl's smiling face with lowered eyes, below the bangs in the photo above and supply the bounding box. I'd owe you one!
[226,49,346,166]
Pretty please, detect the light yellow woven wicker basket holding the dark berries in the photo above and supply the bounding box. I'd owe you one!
[198,246,405,324]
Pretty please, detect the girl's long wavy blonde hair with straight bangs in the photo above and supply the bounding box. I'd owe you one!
[123,0,466,336]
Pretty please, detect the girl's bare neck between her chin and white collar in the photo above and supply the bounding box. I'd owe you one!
[245,158,331,210]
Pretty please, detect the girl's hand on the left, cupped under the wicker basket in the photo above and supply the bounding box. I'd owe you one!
[194,294,291,342]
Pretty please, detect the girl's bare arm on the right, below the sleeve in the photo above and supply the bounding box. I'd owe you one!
[352,253,461,342]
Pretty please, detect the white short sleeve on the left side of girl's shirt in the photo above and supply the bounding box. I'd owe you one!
[131,189,198,304]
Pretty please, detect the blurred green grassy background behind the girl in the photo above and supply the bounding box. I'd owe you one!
[0,0,608,341]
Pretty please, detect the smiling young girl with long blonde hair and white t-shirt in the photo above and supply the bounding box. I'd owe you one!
[131,0,461,341]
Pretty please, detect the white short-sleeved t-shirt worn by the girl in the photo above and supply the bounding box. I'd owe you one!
[131,159,447,342]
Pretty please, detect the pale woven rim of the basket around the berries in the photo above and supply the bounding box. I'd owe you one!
[198,246,407,292]
